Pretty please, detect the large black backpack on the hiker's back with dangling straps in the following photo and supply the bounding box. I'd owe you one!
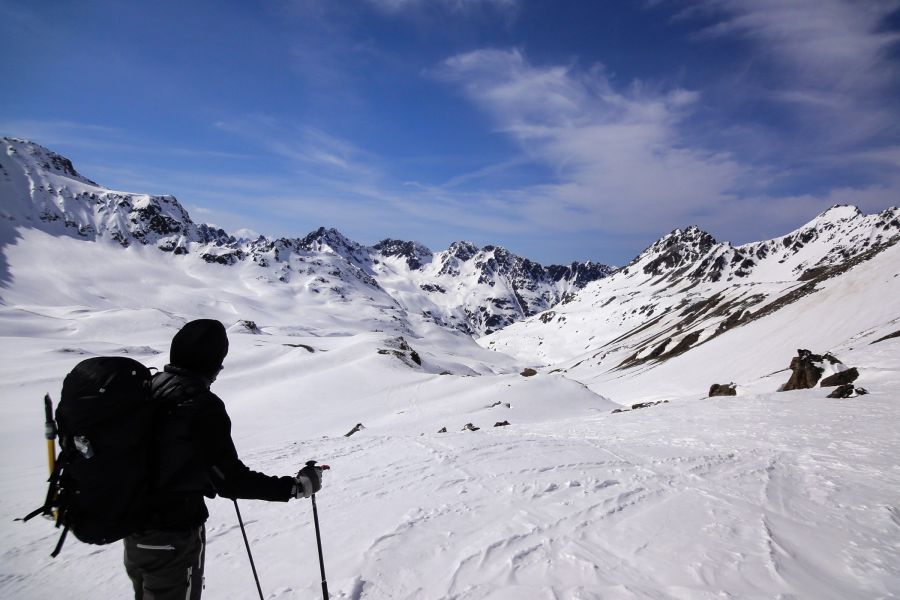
[25,357,158,557]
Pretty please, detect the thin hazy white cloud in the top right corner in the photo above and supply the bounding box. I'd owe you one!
[685,0,900,147]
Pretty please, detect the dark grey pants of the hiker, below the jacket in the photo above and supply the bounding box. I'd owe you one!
[125,525,206,600]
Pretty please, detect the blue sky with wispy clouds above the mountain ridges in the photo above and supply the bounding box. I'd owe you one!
[0,0,900,264]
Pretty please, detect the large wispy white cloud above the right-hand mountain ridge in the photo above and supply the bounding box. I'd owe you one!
[435,49,754,232]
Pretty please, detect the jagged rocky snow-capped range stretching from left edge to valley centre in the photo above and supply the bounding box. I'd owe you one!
[0,138,612,335]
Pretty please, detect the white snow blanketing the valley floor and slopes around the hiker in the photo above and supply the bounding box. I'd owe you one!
[0,139,900,600]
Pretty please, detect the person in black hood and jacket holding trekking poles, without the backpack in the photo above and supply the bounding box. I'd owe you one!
[125,319,322,600]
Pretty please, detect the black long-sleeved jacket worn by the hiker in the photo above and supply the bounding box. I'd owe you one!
[146,365,294,530]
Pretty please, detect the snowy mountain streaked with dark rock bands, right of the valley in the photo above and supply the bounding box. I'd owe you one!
[480,206,900,400]
